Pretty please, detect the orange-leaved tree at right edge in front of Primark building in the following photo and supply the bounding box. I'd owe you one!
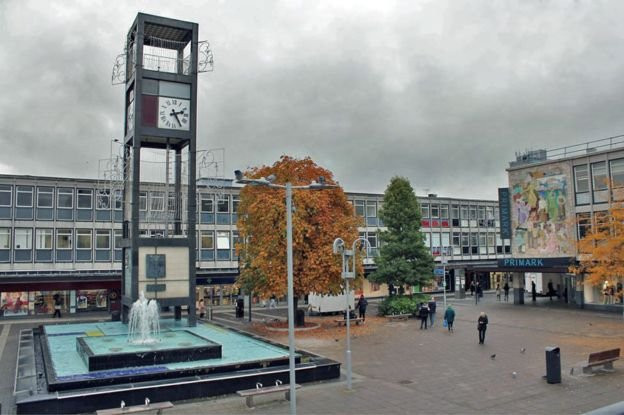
[570,205,624,285]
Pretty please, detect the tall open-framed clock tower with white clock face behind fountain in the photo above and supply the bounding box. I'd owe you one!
[122,13,202,326]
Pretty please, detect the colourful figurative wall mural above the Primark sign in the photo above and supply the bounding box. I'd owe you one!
[509,165,574,256]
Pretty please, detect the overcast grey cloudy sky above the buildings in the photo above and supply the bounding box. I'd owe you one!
[0,0,624,199]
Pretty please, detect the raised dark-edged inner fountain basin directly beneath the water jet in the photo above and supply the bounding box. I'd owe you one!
[76,330,221,371]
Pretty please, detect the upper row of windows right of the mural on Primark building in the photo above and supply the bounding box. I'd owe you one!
[574,158,624,205]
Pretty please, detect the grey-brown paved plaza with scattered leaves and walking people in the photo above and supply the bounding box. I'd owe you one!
[0,294,624,414]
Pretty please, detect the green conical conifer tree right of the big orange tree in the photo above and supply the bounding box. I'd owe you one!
[369,177,434,286]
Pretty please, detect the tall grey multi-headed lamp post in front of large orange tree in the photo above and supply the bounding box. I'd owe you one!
[234,170,338,415]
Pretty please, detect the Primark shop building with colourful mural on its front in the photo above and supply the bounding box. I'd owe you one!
[497,136,624,311]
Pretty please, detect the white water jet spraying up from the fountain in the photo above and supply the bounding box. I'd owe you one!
[128,291,160,344]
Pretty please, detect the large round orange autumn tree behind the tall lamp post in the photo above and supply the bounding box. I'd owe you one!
[236,156,361,298]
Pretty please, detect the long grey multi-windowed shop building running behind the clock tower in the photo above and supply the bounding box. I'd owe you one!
[0,175,511,317]
